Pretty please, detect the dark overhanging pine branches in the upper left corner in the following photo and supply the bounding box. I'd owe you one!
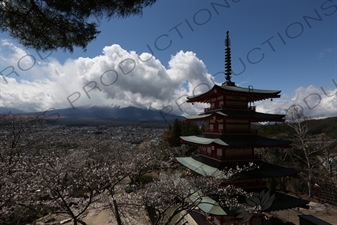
[0,0,156,52]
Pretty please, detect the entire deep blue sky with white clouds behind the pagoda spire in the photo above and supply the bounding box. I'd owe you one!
[0,0,337,117]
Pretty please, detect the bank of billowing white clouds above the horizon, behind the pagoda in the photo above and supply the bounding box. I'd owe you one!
[0,40,337,117]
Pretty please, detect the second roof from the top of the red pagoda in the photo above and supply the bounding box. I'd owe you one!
[185,110,285,122]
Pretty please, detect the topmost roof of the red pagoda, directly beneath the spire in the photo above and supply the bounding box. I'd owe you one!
[187,85,281,102]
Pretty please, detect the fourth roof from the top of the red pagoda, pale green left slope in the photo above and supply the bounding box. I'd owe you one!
[176,155,299,180]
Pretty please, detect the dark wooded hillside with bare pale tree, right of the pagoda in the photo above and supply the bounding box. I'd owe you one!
[257,115,337,200]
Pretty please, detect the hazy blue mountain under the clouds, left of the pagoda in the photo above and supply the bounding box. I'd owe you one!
[0,106,184,124]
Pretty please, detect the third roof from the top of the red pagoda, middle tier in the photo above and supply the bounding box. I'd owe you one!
[180,134,291,147]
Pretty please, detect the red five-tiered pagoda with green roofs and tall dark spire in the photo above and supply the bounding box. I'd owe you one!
[177,31,308,225]
